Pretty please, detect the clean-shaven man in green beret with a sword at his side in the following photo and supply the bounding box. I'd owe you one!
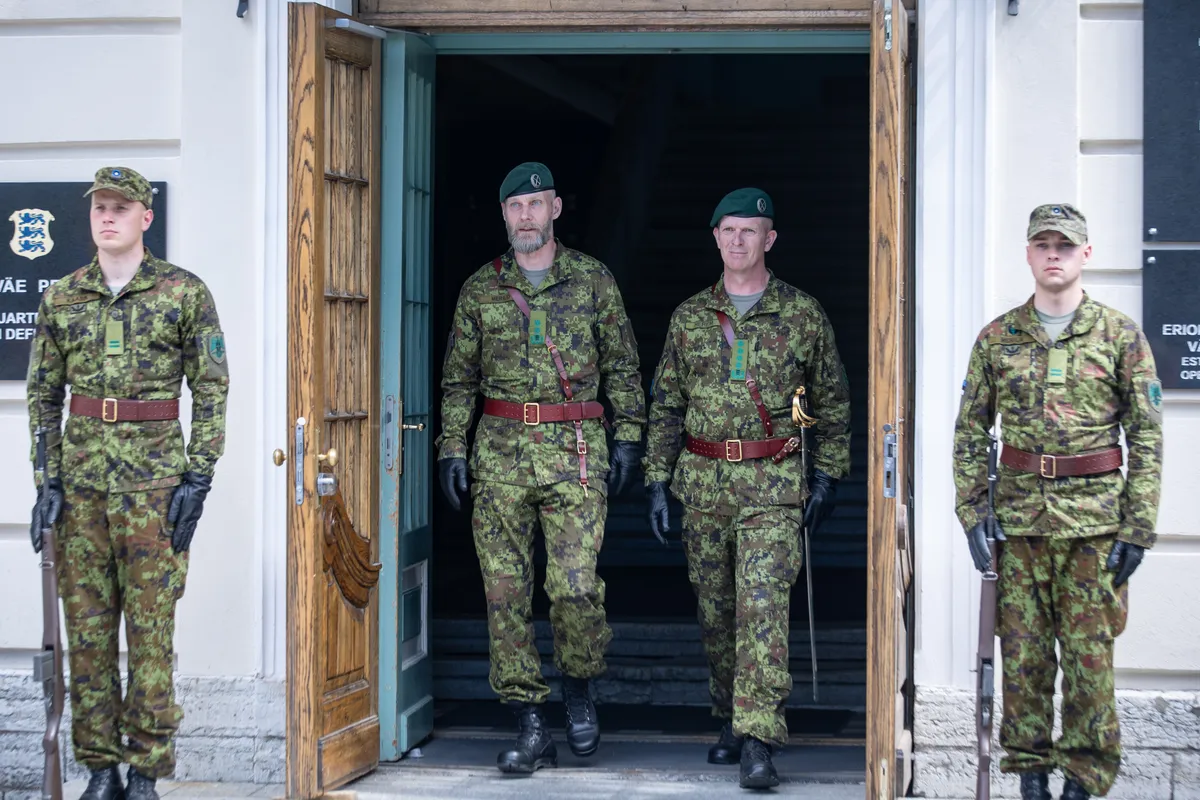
[644,188,850,788]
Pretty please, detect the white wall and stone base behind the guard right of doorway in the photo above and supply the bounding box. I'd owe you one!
[916,0,1200,798]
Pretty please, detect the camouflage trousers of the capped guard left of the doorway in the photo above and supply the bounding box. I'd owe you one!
[58,483,187,777]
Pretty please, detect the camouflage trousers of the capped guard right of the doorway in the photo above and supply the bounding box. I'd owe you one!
[997,536,1128,795]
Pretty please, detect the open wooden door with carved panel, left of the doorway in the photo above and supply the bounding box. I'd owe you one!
[287,4,379,798]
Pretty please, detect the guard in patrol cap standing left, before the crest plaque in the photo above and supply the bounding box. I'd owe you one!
[26,167,229,800]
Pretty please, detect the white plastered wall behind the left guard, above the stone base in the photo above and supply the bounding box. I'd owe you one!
[0,0,266,675]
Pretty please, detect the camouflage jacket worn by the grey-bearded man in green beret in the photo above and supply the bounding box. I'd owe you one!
[438,242,646,486]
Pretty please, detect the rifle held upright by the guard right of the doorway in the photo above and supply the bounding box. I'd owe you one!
[976,431,1000,800]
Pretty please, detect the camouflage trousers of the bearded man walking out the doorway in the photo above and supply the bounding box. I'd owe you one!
[472,480,612,703]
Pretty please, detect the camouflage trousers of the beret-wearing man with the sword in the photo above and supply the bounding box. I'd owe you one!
[683,506,804,745]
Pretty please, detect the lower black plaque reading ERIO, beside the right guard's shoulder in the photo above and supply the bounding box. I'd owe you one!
[1141,249,1200,389]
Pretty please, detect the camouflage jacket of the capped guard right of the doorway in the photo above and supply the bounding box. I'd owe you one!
[954,295,1163,547]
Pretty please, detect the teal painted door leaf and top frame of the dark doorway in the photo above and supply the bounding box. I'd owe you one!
[369,30,870,762]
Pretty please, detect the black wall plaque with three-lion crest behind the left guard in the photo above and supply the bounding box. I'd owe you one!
[0,181,167,380]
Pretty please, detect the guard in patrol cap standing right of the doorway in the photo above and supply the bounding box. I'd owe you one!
[954,203,1163,800]
